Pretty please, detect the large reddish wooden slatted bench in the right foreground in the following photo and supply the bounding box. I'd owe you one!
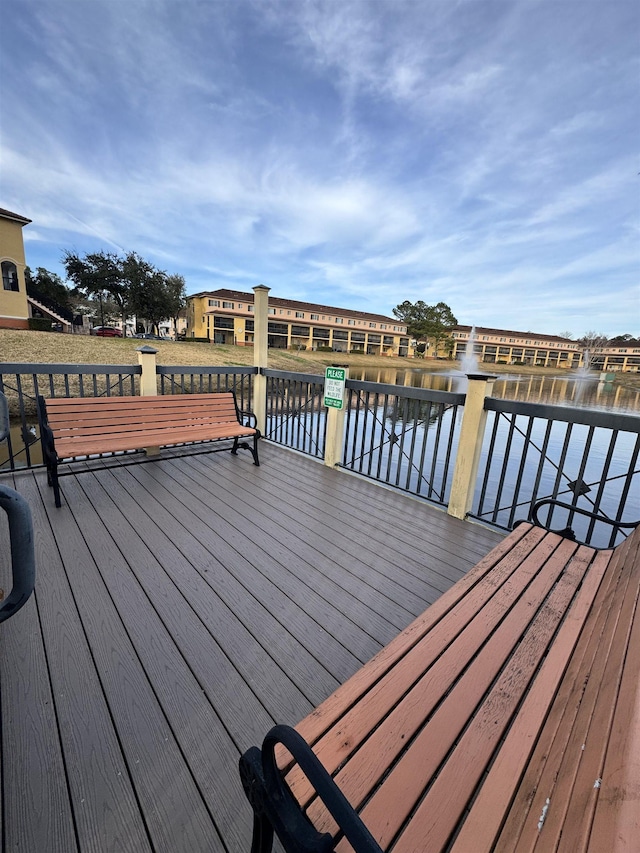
[240,524,640,853]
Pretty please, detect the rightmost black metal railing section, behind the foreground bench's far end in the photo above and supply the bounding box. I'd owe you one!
[470,398,640,547]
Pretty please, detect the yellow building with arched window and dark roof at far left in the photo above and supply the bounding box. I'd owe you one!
[0,208,31,329]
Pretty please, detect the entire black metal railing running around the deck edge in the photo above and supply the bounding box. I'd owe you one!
[0,364,640,547]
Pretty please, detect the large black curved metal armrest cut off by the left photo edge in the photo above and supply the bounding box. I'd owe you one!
[0,486,36,622]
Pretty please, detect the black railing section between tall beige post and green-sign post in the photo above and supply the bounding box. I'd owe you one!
[263,370,327,459]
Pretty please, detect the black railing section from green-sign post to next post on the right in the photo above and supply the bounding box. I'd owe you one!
[342,380,465,504]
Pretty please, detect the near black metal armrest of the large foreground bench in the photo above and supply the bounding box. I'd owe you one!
[240,725,382,853]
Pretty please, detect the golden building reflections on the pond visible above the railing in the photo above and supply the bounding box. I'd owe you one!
[349,367,640,413]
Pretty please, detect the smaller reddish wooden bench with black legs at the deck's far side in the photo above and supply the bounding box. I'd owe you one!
[38,391,260,507]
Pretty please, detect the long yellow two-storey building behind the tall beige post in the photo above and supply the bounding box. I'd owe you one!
[187,289,409,356]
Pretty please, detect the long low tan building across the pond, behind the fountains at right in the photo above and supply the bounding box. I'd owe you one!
[452,326,640,373]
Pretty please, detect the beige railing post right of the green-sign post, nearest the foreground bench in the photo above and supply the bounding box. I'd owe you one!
[447,374,496,518]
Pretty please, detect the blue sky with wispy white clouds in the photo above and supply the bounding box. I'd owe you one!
[0,0,640,337]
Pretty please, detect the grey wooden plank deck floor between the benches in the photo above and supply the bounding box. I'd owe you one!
[0,442,502,853]
